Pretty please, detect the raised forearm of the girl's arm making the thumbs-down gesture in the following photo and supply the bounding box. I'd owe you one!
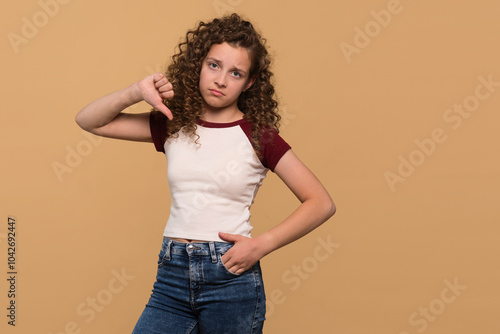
[75,82,142,132]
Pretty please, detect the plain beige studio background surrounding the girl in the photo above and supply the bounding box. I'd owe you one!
[0,0,500,334]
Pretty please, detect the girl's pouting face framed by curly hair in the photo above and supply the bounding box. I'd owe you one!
[200,42,254,112]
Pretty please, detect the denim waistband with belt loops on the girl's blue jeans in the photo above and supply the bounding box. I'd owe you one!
[163,236,234,263]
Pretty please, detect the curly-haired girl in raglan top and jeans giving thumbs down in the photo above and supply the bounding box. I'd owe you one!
[76,14,335,334]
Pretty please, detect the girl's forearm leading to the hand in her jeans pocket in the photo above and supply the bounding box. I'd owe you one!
[255,197,335,256]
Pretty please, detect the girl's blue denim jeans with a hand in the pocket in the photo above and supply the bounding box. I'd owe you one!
[132,237,266,334]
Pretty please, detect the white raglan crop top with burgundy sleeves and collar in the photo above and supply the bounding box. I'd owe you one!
[150,111,290,241]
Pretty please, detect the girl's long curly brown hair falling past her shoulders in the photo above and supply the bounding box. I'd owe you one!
[156,13,281,156]
